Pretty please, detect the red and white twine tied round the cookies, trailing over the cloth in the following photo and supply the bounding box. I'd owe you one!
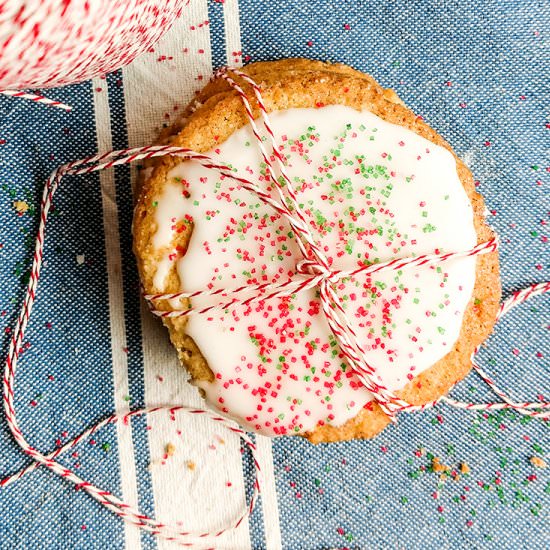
[0,70,550,547]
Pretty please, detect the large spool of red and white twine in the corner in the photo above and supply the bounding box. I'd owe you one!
[0,0,187,90]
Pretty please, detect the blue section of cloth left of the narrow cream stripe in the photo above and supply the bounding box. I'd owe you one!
[0,83,127,548]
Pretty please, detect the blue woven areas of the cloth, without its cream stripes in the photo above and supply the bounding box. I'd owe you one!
[0,0,550,549]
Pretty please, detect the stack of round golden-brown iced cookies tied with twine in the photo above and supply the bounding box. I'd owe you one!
[133,59,500,443]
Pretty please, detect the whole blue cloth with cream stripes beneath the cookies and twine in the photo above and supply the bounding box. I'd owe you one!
[0,0,550,550]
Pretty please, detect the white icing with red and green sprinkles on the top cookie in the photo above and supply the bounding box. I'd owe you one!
[153,106,477,435]
